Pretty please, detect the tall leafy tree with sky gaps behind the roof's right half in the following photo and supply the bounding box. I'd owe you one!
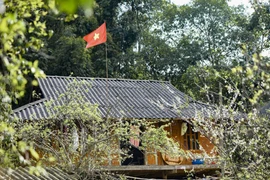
[116,1,251,90]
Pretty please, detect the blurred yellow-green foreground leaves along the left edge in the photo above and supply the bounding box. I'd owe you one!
[0,0,94,172]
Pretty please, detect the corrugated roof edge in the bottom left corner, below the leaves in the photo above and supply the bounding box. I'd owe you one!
[0,167,77,180]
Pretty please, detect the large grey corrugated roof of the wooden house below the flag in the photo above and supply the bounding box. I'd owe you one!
[14,76,214,119]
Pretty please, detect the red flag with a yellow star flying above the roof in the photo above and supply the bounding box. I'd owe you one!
[83,23,107,48]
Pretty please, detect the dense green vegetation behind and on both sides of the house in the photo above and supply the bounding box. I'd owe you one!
[0,0,270,179]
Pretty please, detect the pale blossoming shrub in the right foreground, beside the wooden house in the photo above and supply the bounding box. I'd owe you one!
[189,51,269,179]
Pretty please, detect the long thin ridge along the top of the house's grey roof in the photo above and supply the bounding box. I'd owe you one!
[46,75,171,84]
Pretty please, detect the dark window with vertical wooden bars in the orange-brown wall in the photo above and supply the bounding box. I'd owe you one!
[184,124,200,150]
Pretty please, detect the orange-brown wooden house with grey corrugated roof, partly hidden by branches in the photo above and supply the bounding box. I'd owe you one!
[14,76,219,178]
